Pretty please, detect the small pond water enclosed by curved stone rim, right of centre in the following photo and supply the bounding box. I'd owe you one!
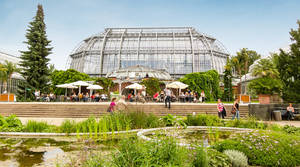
[145,129,241,146]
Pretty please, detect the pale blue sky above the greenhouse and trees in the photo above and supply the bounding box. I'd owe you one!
[0,0,300,69]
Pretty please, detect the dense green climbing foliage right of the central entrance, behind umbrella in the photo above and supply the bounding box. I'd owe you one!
[180,70,221,101]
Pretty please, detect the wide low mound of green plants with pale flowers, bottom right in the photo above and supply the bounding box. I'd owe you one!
[213,131,300,166]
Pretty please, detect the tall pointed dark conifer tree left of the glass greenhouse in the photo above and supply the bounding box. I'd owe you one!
[18,5,52,100]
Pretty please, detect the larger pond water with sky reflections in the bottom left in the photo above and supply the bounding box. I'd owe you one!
[0,137,118,167]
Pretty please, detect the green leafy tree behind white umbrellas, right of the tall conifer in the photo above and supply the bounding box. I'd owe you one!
[50,69,91,94]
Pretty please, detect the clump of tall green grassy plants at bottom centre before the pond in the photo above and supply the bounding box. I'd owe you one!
[112,139,189,167]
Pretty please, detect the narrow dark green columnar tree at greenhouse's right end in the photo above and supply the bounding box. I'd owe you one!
[223,60,233,101]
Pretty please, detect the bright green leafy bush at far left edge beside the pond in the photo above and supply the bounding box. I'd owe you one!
[0,115,24,132]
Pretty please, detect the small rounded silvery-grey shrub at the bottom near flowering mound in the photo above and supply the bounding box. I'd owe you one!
[224,150,248,167]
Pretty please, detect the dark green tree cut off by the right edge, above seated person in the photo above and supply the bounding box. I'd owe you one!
[277,20,300,103]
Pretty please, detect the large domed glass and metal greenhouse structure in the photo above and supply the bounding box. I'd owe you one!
[68,27,229,78]
